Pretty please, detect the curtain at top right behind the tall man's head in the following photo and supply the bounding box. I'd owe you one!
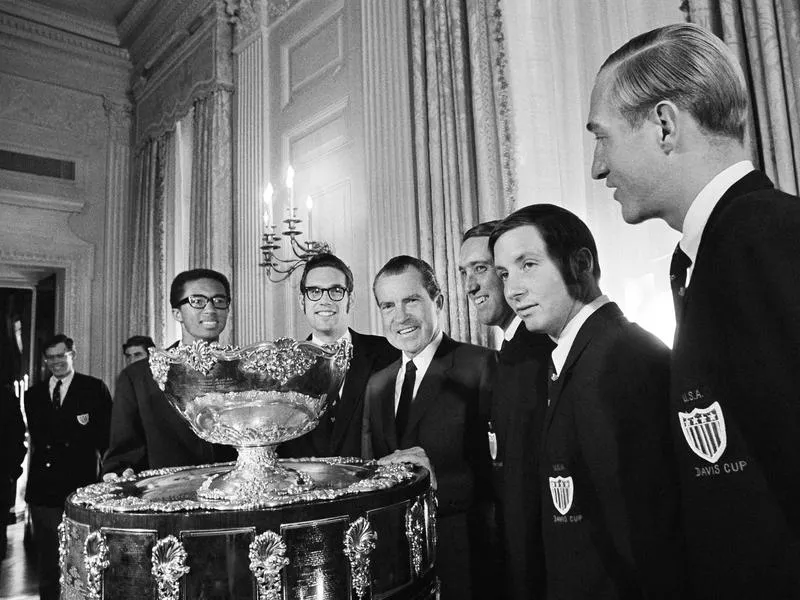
[687,0,800,194]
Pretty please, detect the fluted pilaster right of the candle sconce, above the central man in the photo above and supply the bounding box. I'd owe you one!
[361,0,419,331]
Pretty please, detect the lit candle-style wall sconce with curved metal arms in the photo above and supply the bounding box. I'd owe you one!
[259,165,331,283]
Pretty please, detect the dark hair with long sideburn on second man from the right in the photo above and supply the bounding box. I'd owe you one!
[489,204,600,298]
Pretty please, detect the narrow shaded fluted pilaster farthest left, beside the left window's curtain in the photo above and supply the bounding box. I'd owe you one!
[103,98,133,387]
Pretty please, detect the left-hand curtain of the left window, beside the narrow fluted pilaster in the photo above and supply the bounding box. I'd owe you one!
[129,131,175,347]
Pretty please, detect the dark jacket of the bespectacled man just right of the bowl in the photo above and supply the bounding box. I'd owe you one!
[278,329,400,458]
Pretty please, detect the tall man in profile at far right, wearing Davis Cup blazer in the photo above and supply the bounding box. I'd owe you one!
[588,24,800,598]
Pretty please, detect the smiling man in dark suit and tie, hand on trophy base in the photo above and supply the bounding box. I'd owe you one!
[364,256,496,600]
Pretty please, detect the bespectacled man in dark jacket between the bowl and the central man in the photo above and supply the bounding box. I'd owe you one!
[278,254,400,457]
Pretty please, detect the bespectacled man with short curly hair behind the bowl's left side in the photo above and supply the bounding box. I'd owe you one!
[103,269,236,479]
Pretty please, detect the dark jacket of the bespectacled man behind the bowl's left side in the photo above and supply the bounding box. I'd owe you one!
[103,360,236,474]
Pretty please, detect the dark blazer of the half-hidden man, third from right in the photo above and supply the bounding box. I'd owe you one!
[491,323,555,600]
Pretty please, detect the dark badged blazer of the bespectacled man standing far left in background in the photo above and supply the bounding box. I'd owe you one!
[25,373,111,506]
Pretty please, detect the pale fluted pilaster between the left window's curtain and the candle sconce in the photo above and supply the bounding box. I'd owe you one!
[229,0,273,345]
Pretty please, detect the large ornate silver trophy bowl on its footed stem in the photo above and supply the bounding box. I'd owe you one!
[150,338,352,504]
